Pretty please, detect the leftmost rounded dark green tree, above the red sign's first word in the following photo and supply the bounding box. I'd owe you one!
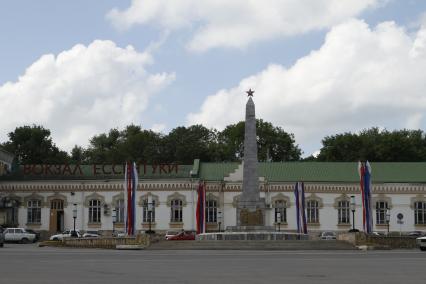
[3,125,70,164]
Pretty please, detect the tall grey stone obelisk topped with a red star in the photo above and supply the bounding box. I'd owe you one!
[237,89,265,226]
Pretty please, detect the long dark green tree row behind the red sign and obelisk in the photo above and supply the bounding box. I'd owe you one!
[3,120,301,164]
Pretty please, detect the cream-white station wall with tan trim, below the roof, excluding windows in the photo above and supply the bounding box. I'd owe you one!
[0,179,426,235]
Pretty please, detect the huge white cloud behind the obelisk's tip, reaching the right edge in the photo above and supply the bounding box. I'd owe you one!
[187,20,426,155]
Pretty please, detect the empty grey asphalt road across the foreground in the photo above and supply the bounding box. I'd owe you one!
[0,244,426,284]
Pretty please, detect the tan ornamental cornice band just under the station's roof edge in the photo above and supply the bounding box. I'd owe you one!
[0,179,426,194]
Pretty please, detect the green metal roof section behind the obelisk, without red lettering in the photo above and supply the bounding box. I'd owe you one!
[200,162,426,183]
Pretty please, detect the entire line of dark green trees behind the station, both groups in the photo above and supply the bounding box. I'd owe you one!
[7,124,426,164]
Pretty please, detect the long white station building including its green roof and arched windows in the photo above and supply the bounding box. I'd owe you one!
[0,160,426,235]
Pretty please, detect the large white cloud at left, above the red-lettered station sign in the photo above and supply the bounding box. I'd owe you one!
[0,40,174,150]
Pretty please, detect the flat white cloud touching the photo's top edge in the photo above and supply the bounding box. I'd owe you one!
[107,0,389,51]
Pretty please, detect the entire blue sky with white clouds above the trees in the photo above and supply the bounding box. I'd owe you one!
[0,0,426,156]
